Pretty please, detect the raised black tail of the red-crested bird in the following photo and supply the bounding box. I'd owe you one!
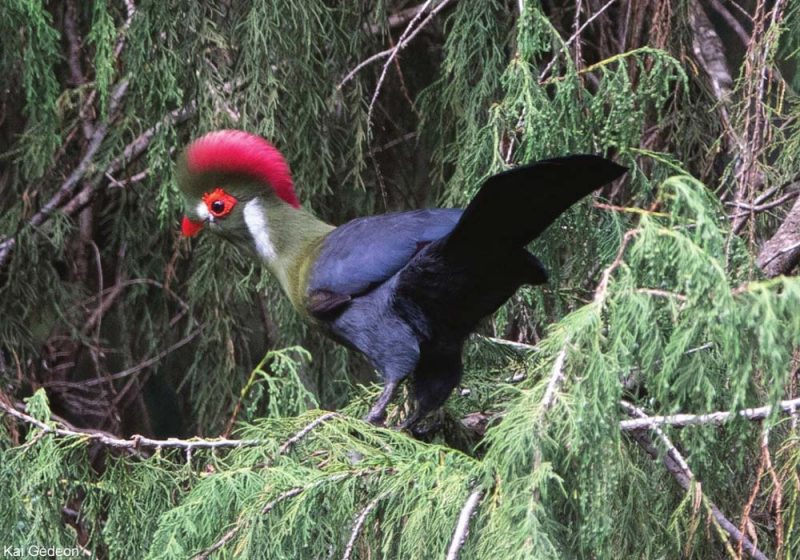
[447,155,627,255]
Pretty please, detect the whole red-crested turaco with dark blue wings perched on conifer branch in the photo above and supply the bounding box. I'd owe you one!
[176,130,627,431]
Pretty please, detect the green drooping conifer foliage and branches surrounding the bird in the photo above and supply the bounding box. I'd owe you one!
[0,0,800,560]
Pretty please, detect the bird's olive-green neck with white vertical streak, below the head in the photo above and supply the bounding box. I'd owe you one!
[244,197,334,311]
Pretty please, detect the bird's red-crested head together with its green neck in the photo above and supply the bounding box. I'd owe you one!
[178,130,333,309]
